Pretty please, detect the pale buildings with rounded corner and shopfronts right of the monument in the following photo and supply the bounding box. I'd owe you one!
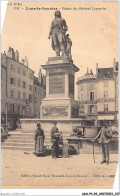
[77,59,118,125]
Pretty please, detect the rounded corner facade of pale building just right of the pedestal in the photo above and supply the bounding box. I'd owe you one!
[77,71,97,118]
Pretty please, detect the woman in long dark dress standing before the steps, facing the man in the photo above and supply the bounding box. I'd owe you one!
[34,123,45,156]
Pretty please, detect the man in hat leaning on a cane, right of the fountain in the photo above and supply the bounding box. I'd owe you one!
[93,120,112,164]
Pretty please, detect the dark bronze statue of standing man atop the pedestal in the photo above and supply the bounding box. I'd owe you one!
[48,10,68,56]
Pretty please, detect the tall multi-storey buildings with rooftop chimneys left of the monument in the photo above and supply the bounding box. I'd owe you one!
[1,47,45,129]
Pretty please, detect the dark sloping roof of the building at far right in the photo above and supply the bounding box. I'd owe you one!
[97,67,113,79]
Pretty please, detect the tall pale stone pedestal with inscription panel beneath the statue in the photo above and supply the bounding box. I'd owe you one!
[41,56,79,119]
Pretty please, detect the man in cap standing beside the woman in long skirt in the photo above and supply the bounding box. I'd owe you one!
[51,121,60,158]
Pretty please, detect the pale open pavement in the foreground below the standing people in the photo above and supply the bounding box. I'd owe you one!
[1,149,118,189]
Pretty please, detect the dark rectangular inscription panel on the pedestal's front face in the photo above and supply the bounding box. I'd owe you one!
[49,72,65,94]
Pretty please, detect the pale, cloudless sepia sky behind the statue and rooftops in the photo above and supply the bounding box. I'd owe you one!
[1,1,118,80]
